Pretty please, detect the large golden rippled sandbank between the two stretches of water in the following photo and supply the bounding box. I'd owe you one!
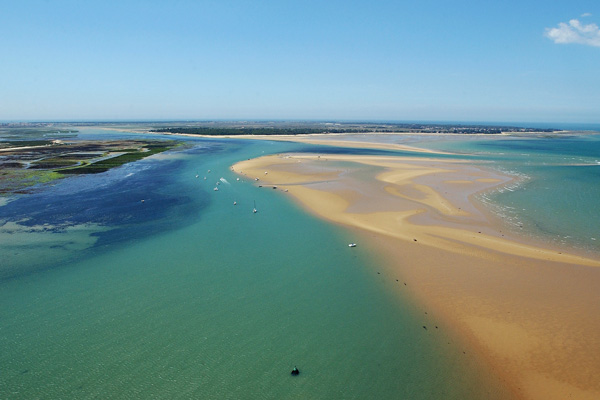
[233,154,600,399]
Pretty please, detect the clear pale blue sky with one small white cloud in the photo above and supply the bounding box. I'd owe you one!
[0,0,600,123]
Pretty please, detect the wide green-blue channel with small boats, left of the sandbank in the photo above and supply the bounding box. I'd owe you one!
[0,133,506,399]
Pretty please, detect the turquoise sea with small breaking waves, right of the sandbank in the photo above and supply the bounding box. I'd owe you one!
[414,135,600,257]
